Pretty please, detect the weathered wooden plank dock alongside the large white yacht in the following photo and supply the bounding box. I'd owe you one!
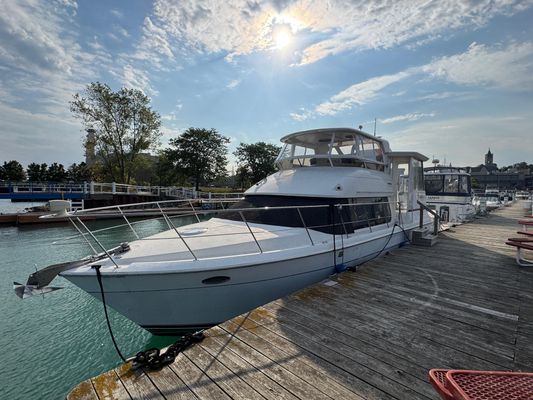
[68,205,533,400]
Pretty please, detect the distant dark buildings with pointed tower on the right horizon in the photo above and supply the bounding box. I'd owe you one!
[466,149,532,190]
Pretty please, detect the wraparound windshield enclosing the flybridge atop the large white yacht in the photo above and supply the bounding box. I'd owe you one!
[276,131,384,170]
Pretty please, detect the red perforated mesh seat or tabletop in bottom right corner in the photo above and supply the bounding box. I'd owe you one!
[445,370,533,400]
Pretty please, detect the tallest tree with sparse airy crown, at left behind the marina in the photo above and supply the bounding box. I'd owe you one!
[70,82,161,183]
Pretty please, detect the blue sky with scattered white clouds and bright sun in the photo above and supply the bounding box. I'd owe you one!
[0,0,533,166]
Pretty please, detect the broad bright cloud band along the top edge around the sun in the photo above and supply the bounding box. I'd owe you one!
[139,0,533,65]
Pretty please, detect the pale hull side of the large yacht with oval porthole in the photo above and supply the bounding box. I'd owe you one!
[63,228,406,335]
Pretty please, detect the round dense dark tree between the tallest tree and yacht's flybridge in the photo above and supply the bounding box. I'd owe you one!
[166,128,229,190]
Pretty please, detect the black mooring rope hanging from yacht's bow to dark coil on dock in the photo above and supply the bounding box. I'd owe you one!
[92,265,205,370]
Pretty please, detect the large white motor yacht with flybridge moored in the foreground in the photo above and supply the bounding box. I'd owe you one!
[15,128,432,335]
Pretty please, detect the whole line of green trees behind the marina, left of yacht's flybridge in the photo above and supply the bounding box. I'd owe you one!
[0,82,280,189]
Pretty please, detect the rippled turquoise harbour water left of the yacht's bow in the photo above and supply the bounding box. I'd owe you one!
[0,200,183,399]
